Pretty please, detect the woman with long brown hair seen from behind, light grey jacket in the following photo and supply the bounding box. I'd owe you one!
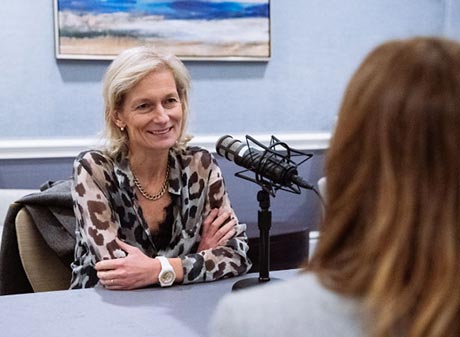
[212,37,460,337]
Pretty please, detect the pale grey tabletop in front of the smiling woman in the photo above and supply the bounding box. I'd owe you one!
[0,270,298,337]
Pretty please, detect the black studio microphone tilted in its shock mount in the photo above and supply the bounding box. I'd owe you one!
[216,135,314,189]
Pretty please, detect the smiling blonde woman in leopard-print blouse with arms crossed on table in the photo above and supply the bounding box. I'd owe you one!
[71,47,251,289]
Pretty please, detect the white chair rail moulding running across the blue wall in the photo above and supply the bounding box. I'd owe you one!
[0,132,330,159]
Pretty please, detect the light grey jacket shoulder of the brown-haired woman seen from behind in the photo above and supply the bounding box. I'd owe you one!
[210,273,365,337]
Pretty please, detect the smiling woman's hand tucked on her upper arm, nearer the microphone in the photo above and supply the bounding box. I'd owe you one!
[198,208,236,252]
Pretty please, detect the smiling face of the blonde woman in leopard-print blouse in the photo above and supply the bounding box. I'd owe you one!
[115,69,182,152]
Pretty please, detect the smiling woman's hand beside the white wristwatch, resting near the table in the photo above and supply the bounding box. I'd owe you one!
[96,238,161,290]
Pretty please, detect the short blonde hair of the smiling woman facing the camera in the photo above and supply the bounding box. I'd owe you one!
[103,46,192,156]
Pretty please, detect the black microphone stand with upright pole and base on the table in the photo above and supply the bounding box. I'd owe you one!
[232,186,278,291]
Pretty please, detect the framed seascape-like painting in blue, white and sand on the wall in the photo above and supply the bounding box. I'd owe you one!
[54,0,271,61]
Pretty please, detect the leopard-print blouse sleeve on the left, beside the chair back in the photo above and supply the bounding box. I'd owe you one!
[72,152,126,266]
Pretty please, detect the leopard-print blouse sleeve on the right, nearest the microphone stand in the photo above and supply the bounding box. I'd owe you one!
[182,155,252,283]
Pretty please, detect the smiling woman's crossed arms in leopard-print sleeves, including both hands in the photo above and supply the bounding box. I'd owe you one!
[72,150,251,289]
